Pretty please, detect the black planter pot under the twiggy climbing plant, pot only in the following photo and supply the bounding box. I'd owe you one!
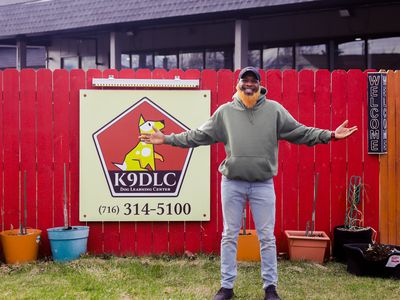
[332,225,376,262]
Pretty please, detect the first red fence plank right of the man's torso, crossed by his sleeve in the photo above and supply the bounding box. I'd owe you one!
[281,70,299,239]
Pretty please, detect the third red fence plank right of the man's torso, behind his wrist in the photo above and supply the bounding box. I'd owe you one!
[315,70,333,234]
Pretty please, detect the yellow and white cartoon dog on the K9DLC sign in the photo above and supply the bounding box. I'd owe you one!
[114,115,165,171]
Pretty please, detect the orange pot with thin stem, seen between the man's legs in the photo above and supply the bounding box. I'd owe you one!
[237,209,260,261]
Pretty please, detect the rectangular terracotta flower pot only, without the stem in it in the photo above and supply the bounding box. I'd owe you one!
[285,230,330,263]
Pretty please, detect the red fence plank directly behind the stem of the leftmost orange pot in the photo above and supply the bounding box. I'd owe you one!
[20,69,37,228]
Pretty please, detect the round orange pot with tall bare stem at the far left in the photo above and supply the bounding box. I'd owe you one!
[0,171,42,264]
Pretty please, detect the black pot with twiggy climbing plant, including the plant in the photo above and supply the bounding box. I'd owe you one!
[332,176,376,262]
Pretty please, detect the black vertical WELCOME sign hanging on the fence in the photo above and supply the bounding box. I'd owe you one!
[367,72,387,154]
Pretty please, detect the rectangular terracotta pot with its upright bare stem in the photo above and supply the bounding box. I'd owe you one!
[285,173,330,263]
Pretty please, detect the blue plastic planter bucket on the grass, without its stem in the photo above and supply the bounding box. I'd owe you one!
[47,226,89,261]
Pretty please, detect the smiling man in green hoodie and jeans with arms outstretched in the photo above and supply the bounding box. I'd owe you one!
[140,67,357,300]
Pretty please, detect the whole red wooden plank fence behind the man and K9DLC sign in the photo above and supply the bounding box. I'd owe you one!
[0,69,379,255]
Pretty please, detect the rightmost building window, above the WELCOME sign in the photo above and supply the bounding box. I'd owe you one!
[368,37,400,70]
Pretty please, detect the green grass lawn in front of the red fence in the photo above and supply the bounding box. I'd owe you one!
[0,256,400,300]
